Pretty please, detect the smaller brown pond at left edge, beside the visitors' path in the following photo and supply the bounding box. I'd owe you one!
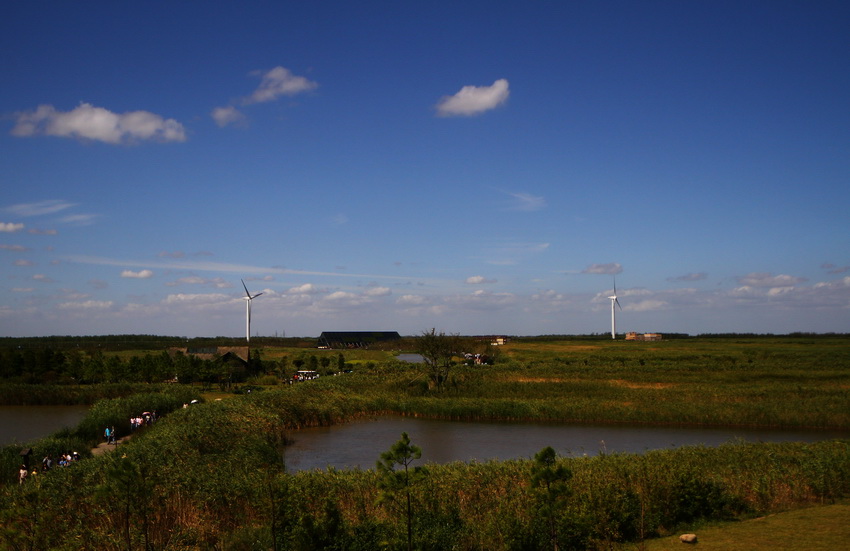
[0,406,89,446]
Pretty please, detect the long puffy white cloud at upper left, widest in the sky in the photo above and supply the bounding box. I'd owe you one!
[11,103,186,144]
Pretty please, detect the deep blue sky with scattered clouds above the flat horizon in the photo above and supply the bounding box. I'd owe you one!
[0,1,850,336]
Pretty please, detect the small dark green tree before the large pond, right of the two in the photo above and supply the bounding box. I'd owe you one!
[531,446,573,551]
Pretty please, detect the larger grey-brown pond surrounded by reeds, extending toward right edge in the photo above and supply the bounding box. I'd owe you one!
[285,416,850,472]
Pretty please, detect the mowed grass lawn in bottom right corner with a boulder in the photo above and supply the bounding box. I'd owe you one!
[627,502,850,551]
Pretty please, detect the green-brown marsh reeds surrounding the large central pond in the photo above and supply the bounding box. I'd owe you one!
[0,337,850,550]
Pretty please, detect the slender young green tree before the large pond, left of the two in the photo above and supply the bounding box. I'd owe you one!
[377,432,428,551]
